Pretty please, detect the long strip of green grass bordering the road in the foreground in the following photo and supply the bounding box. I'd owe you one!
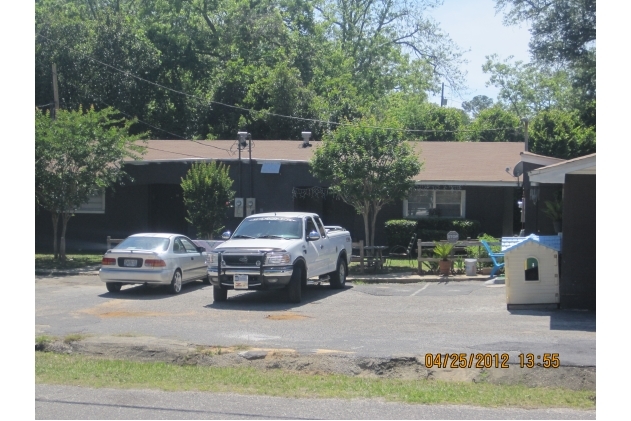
[35,352,596,409]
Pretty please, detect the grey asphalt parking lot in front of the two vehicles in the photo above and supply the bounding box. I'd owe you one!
[35,275,596,366]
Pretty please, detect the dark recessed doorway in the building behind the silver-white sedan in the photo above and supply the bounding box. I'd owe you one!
[148,184,187,234]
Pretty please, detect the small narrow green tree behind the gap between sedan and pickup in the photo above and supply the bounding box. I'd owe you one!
[181,162,235,239]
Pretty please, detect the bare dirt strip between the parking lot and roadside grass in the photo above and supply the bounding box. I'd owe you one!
[36,336,596,391]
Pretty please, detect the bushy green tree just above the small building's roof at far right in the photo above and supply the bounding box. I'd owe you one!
[528,110,596,159]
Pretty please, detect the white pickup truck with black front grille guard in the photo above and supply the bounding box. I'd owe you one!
[208,212,351,303]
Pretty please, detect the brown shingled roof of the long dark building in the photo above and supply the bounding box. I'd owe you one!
[130,140,524,186]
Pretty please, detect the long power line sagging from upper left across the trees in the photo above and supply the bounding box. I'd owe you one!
[36,33,513,133]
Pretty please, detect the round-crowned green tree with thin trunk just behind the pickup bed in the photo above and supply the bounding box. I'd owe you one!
[310,117,422,245]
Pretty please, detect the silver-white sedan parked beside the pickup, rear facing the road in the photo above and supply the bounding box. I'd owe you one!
[99,233,209,294]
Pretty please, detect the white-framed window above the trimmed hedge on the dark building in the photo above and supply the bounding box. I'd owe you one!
[403,189,465,218]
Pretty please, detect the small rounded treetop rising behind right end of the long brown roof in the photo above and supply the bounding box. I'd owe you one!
[467,105,524,142]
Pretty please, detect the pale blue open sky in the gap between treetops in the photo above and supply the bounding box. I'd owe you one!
[427,0,530,108]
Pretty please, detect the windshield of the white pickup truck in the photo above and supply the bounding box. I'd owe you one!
[232,216,302,239]
